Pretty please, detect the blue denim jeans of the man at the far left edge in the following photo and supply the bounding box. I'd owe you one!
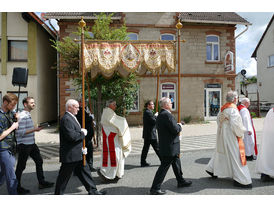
[0,150,17,195]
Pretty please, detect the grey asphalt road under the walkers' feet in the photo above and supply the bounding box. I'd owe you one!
[0,149,274,195]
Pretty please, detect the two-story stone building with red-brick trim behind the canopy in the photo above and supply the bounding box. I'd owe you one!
[45,12,250,125]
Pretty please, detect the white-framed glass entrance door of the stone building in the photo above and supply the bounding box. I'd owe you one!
[204,88,222,120]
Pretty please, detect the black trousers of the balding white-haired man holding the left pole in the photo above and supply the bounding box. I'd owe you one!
[54,161,97,195]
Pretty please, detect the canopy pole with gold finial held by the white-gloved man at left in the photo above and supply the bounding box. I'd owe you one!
[79,17,86,166]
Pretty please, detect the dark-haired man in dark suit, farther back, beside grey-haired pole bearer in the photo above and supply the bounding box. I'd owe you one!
[141,100,160,167]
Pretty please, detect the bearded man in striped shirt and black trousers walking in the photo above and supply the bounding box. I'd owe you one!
[15,97,54,194]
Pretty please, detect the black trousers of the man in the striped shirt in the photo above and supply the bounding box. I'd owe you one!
[15,144,45,187]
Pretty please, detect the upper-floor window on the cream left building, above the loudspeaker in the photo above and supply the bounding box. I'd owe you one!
[8,40,28,61]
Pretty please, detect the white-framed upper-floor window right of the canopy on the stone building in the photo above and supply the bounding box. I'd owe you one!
[206,35,220,61]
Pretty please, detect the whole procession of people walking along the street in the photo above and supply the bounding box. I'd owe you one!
[0,91,274,195]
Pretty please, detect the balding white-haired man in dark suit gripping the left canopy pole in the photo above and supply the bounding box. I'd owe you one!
[55,99,105,195]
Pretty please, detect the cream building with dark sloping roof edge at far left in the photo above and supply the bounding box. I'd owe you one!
[0,12,57,124]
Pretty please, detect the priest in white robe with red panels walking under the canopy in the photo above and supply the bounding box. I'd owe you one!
[98,100,131,181]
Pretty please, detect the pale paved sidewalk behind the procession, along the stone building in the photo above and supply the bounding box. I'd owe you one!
[23,118,264,160]
